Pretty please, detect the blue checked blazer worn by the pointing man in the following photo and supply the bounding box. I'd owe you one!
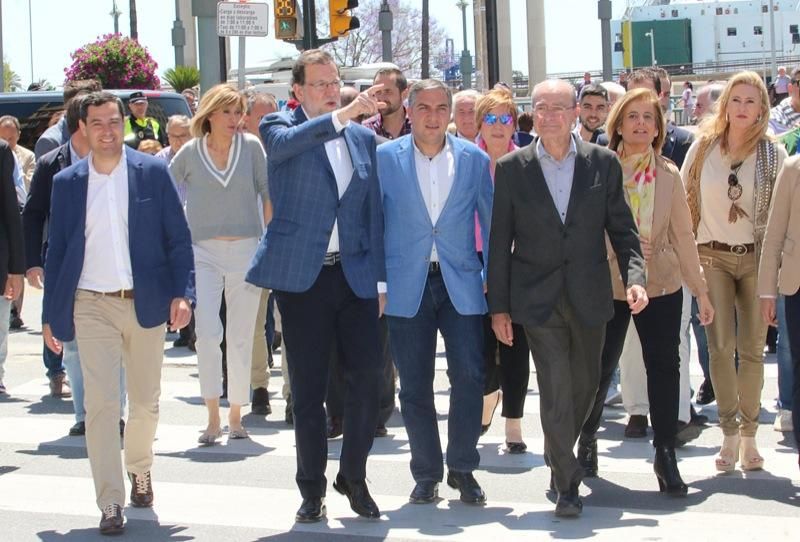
[247,108,386,299]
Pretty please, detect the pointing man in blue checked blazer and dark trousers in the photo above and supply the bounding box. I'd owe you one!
[247,49,386,522]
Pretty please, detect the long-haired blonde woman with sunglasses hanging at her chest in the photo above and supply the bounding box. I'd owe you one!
[681,71,786,472]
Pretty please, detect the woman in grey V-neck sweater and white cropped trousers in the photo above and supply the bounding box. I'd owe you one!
[169,84,272,445]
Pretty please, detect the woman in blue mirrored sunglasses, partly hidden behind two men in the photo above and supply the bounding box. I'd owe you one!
[475,88,530,454]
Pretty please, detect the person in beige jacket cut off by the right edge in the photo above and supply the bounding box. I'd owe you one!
[758,156,800,465]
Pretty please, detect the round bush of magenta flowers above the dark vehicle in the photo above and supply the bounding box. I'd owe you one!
[64,34,161,90]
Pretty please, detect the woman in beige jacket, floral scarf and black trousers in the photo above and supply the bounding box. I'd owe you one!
[578,89,714,496]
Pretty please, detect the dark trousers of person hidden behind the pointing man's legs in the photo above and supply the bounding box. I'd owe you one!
[325,318,397,427]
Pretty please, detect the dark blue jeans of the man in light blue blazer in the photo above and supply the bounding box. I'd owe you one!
[387,273,484,482]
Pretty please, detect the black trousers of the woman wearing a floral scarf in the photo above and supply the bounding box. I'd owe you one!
[580,290,683,446]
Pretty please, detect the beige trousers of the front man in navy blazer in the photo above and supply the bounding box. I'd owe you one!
[74,290,166,510]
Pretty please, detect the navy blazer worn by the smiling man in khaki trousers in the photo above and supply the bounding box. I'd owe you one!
[42,149,195,341]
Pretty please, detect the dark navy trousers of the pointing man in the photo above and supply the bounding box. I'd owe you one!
[275,263,383,499]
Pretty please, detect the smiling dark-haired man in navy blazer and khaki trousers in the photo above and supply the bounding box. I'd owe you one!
[42,92,194,534]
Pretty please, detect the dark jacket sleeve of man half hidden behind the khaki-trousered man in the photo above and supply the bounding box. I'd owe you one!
[22,142,72,269]
